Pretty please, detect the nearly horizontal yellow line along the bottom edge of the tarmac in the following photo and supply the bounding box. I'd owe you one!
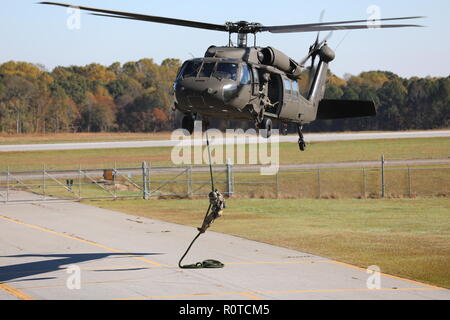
[118,288,445,300]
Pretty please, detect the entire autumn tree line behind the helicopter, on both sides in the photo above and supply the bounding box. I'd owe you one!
[0,59,450,134]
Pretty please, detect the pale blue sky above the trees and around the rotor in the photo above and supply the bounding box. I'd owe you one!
[0,0,450,78]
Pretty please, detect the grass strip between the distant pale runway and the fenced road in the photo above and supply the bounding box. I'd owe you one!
[0,138,450,170]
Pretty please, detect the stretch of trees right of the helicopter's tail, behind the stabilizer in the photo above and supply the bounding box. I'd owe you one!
[308,71,450,132]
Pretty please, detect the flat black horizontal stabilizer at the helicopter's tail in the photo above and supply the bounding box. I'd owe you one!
[317,100,377,120]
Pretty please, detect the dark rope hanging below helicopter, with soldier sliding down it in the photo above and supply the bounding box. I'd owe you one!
[178,128,225,269]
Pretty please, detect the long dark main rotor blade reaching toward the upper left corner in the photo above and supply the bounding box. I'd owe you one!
[39,1,228,32]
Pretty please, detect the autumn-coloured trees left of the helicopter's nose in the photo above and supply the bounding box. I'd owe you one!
[0,59,181,133]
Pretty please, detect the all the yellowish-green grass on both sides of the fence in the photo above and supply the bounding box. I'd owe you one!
[0,134,450,288]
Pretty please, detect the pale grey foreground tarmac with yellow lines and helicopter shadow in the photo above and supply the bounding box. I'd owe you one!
[0,191,450,300]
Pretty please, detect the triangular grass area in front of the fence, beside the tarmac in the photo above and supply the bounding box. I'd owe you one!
[87,198,450,288]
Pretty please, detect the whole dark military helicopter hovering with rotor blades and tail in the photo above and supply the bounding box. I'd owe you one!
[41,2,423,151]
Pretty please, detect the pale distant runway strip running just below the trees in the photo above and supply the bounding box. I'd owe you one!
[0,131,450,152]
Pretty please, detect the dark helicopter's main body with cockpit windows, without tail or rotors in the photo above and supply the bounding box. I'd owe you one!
[174,47,317,124]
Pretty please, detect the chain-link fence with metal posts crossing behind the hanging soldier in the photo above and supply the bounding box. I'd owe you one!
[0,162,450,203]
